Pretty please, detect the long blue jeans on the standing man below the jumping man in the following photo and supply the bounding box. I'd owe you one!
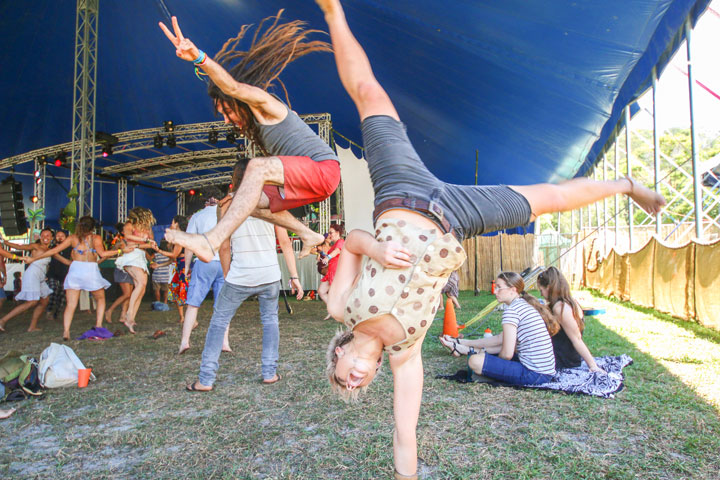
[198,282,280,387]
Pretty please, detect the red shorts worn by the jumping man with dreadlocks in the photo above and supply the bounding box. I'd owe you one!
[263,157,340,213]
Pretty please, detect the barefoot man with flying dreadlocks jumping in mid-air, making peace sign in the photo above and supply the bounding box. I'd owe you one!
[160,10,340,261]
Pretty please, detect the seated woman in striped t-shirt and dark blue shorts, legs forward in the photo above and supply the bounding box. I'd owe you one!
[440,272,557,385]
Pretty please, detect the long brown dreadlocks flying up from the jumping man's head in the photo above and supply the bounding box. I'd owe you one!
[208,10,332,155]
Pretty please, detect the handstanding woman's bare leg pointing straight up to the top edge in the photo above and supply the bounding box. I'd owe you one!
[317,0,400,120]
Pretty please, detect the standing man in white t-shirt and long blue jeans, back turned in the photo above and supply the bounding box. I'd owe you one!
[187,182,303,391]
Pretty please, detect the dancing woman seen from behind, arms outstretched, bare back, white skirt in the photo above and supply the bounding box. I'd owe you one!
[23,215,127,340]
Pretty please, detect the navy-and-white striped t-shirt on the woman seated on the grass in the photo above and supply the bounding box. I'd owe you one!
[502,297,555,375]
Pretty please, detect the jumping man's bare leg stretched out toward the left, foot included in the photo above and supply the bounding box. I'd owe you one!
[165,157,284,262]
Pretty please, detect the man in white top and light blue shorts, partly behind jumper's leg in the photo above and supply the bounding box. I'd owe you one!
[178,187,230,354]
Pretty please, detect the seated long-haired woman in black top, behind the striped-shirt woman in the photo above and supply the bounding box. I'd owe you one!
[538,267,605,373]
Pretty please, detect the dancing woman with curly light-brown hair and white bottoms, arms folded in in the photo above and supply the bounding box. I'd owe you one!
[115,207,155,334]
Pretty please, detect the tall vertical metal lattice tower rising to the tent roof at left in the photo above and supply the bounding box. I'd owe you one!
[70,0,99,218]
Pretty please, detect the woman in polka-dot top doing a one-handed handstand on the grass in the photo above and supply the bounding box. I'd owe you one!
[316,0,664,478]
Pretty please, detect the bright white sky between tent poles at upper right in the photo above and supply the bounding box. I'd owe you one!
[632,0,720,135]
